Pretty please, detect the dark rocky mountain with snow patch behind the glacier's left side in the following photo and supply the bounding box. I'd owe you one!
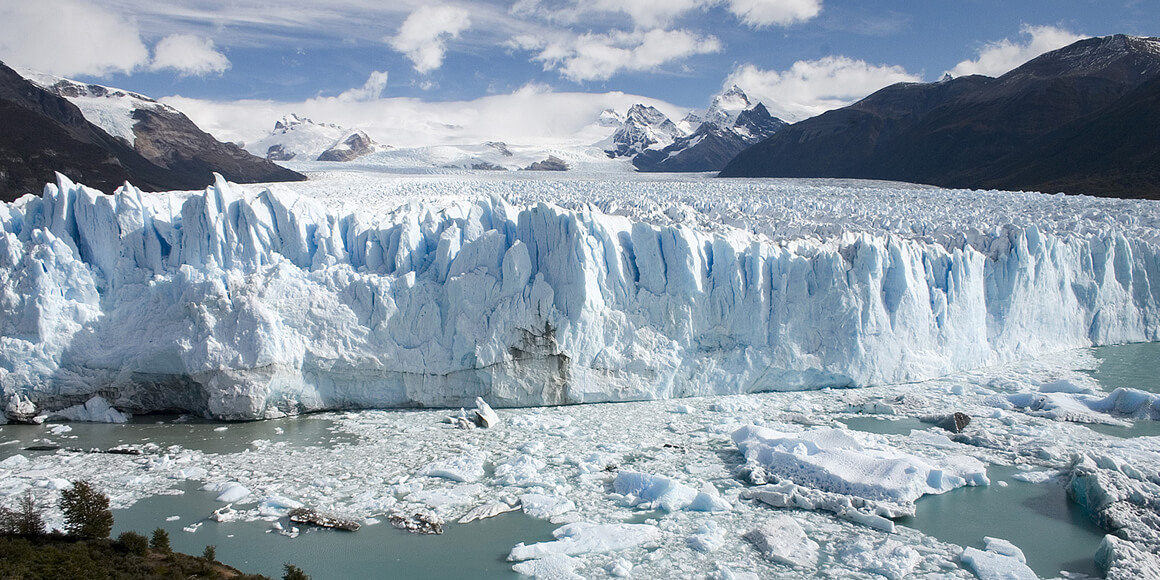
[0,64,305,201]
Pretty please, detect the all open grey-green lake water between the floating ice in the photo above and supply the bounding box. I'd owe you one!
[0,343,1160,580]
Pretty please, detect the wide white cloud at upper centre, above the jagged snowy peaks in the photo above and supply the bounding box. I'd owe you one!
[522,28,722,82]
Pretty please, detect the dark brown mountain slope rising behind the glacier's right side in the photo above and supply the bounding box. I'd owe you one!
[720,35,1160,198]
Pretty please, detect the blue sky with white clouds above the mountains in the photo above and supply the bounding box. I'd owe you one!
[0,0,1160,145]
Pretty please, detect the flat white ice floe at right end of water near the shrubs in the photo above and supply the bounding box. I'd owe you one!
[508,522,660,561]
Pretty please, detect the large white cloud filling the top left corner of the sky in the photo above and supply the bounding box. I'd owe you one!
[0,0,148,77]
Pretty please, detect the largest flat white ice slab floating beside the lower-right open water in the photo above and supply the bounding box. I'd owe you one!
[733,426,989,503]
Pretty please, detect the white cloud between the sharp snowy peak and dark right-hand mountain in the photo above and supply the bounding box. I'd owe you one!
[724,56,921,122]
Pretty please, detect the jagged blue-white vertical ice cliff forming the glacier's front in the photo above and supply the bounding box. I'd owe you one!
[0,176,1160,419]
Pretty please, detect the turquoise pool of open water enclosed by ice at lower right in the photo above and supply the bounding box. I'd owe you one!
[897,465,1104,578]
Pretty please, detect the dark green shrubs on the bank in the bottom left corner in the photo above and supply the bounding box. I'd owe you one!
[0,481,310,580]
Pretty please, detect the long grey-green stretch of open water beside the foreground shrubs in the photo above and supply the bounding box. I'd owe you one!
[113,477,558,580]
